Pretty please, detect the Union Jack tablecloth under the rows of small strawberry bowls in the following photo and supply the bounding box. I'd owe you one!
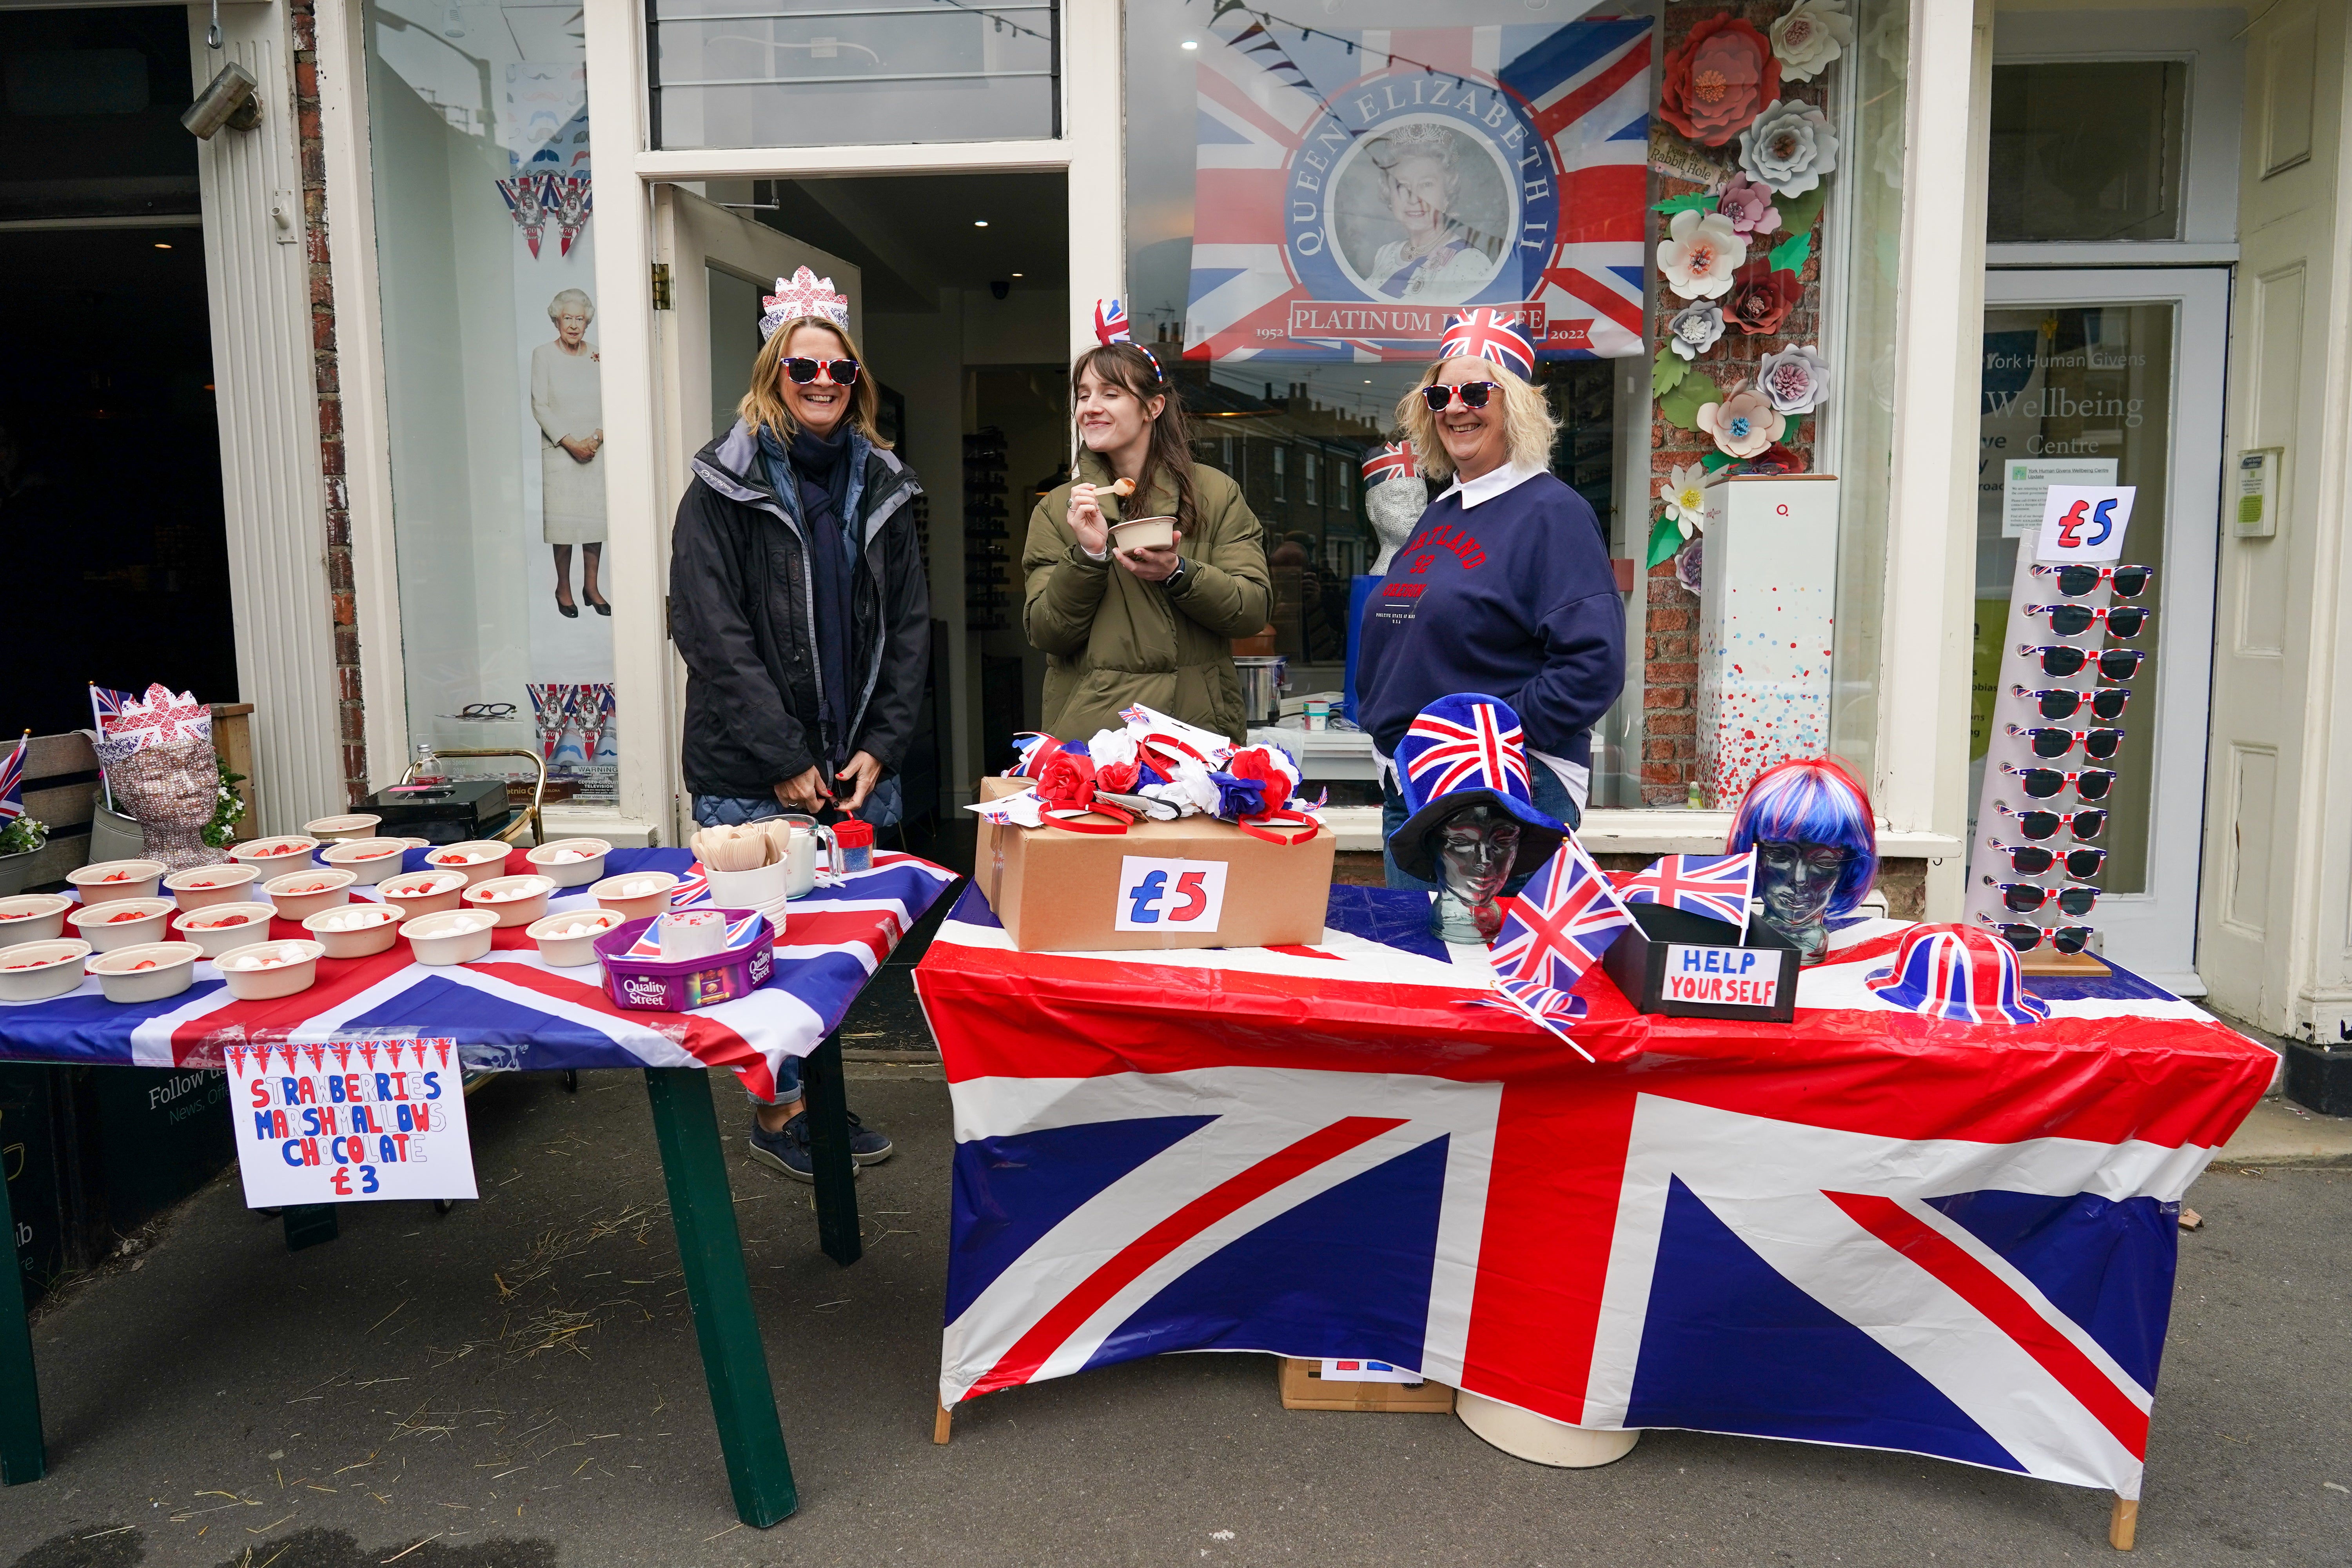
[0,849,955,1096]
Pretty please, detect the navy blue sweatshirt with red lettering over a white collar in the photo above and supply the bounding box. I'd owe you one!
[1355,472,1625,766]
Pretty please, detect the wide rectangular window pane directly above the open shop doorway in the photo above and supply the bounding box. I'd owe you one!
[649,0,1061,148]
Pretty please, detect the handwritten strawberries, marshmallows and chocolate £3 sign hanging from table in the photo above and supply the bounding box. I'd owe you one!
[223,1039,475,1208]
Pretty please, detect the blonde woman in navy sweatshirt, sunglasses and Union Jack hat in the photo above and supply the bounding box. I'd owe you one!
[1355,310,1625,889]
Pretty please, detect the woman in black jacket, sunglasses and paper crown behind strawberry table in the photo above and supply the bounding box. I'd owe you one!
[670,268,931,1180]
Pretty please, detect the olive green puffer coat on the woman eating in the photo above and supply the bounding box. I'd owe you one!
[1021,451,1272,743]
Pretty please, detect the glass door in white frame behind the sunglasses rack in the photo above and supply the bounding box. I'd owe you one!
[1969,268,2230,997]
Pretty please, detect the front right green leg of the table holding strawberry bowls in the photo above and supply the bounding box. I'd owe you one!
[644,1067,800,1530]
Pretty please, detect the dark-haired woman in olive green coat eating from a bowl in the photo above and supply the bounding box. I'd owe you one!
[1021,324,1272,743]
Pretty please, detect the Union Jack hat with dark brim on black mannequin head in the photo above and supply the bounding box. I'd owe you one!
[1388,691,1569,882]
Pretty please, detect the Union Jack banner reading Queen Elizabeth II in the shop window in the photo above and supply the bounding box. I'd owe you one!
[1183,16,1656,362]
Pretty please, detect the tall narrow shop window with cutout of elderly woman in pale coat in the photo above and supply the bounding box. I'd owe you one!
[362,0,619,802]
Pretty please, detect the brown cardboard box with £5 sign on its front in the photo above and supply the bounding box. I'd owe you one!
[974,778,1338,952]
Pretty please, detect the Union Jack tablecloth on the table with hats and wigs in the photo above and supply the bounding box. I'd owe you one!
[915,889,2277,1497]
